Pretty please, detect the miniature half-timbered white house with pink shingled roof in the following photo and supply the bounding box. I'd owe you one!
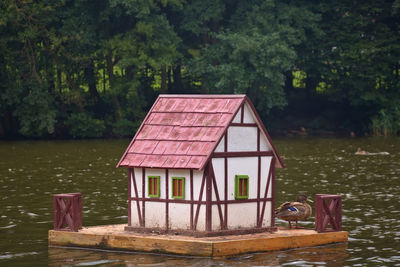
[117,95,284,235]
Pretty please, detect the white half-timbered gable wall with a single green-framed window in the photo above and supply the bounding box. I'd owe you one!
[211,104,273,230]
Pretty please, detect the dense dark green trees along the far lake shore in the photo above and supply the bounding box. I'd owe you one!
[0,0,400,138]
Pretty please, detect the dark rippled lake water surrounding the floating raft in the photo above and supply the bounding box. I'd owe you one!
[0,137,400,266]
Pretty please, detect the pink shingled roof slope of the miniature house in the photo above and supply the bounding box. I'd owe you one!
[118,95,246,169]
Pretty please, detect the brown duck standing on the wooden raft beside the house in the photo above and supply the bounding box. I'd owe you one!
[275,193,313,229]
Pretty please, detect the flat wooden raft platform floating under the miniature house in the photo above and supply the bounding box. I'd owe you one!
[49,224,348,257]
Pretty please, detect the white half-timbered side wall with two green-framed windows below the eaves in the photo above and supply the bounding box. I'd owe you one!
[130,168,205,231]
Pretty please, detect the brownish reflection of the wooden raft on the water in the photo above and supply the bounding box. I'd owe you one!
[49,244,348,266]
